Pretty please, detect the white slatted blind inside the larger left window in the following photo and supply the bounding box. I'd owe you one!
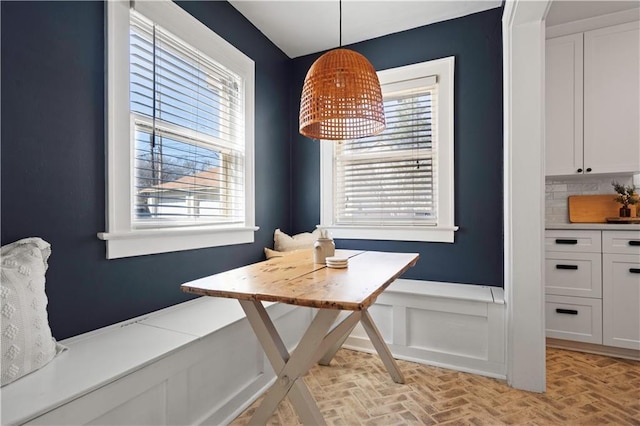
[129,11,245,228]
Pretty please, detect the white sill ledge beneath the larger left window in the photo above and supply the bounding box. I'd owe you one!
[98,226,259,259]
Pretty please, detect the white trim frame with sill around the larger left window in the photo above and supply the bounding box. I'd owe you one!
[98,0,258,259]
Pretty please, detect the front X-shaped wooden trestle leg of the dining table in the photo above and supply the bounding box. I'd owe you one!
[240,300,340,424]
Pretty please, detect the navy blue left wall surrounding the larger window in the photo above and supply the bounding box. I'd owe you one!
[1,1,291,339]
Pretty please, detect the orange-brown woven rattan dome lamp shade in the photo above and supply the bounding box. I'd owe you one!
[300,49,385,140]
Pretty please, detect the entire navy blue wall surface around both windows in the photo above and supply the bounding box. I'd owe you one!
[0,1,502,339]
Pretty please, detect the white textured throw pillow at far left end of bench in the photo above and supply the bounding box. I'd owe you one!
[0,238,62,386]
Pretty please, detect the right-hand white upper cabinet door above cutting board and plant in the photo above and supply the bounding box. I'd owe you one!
[584,21,640,173]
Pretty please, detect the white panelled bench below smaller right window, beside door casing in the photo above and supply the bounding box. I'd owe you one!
[345,279,506,379]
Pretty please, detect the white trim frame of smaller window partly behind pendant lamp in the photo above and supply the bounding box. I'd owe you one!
[318,56,458,243]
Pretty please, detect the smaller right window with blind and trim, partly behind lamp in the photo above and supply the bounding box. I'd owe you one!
[321,57,457,242]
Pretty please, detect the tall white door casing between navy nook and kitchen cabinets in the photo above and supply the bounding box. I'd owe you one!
[502,0,551,392]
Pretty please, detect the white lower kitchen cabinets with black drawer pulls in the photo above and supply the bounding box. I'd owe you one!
[545,230,640,352]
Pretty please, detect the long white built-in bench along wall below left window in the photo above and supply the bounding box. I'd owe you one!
[1,297,311,425]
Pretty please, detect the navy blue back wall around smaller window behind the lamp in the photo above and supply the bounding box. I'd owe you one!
[291,6,503,286]
